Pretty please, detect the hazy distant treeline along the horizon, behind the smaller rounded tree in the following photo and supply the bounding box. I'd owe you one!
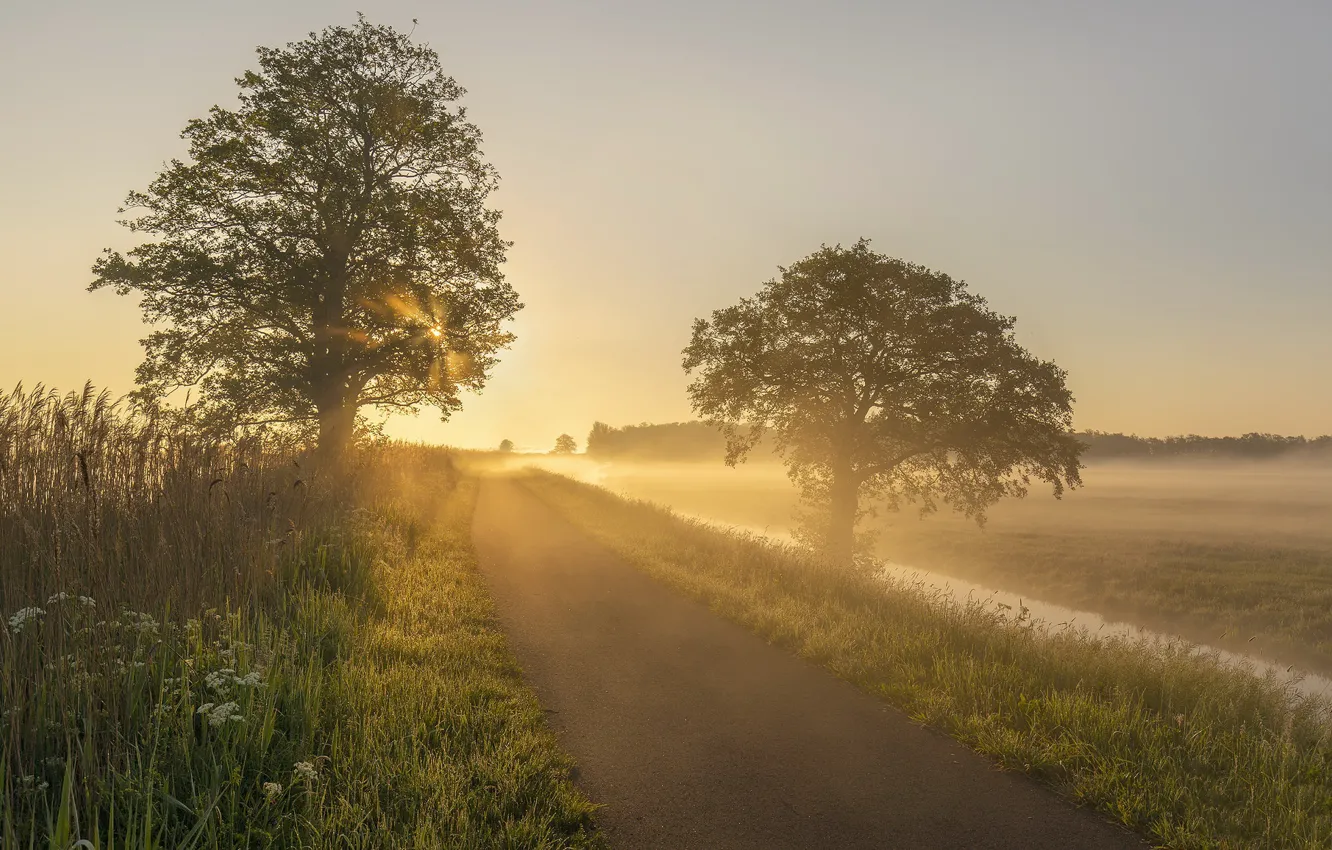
[587,422,1332,461]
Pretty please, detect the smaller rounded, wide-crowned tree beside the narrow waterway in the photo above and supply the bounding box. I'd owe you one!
[685,240,1083,562]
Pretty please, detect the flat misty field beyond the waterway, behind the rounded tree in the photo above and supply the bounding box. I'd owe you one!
[514,460,1332,673]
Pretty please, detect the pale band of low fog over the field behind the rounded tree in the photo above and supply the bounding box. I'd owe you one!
[515,456,1332,548]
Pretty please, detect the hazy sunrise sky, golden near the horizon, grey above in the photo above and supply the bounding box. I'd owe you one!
[0,0,1332,449]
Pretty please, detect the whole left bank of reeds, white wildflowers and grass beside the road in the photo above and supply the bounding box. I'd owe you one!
[0,393,599,849]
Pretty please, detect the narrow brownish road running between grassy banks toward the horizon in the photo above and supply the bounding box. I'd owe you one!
[474,478,1144,850]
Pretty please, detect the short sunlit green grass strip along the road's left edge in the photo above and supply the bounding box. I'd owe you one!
[305,480,601,850]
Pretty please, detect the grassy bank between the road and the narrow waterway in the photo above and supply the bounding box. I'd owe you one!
[522,473,1332,850]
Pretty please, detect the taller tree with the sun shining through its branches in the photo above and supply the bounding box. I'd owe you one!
[91,17,522,454]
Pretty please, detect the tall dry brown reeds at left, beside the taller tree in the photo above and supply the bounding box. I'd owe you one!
[0,385,319,609]
